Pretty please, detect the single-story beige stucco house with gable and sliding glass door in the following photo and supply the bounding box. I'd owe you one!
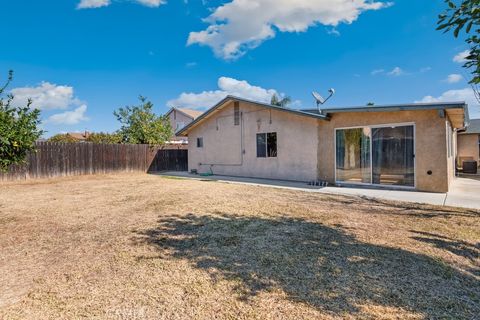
[177,96,468,192]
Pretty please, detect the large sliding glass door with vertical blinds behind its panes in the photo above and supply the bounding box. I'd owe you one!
[335,125,415,187]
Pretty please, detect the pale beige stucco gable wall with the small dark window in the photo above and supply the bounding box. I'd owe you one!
[188,102,321,181]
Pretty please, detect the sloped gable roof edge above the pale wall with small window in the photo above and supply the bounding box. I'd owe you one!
[175,95,328,135]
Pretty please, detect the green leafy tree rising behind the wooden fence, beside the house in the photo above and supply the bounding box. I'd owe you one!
[113,96,173,144]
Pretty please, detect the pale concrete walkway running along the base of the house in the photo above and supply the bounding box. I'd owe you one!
[159,172,480,209]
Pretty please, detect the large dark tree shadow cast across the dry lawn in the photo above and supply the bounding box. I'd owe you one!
[136,214,480,319]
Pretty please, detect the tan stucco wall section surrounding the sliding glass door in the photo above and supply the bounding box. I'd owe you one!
[318,110,454,192]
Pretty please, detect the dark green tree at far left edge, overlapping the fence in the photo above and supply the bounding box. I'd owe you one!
[0,71,43,171]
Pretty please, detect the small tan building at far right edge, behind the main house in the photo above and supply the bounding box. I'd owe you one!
[457,119,480,167]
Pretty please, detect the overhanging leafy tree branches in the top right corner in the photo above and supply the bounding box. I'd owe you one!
[437,0,480,102]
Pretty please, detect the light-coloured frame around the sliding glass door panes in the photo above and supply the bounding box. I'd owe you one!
[333,122,417,190]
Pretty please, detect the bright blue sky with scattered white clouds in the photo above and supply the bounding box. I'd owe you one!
[0,0,480,136]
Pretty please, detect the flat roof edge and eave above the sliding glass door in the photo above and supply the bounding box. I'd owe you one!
[303,101,470,128]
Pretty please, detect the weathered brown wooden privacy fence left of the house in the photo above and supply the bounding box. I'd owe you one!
[0,142,188,181]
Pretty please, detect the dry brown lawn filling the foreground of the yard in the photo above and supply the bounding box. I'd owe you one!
[0,174,480,319]
